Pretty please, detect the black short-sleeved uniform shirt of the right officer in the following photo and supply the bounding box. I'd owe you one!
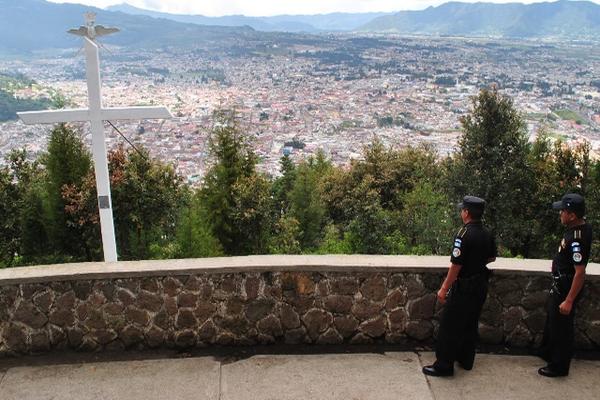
[552,223,592,275]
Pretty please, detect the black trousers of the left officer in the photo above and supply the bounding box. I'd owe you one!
[435,275,488,370]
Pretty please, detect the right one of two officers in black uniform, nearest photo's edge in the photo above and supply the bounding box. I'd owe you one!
[538,193,592,378]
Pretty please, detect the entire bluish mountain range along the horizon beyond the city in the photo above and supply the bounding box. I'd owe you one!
[0,0,600,53]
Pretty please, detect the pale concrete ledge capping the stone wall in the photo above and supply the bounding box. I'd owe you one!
[0,255,600,285]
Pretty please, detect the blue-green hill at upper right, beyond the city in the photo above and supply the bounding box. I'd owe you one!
[359,0,600,39]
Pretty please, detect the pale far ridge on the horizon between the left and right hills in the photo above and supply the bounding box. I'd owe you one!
[107,3,390,32]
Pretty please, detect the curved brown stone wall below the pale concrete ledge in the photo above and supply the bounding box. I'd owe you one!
[0,258,600,356]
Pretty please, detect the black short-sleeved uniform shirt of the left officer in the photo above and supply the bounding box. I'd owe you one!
[450,221,498,278]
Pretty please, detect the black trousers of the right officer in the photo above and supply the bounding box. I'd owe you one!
[539,289,581,374]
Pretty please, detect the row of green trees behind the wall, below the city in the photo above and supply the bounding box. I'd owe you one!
[0,88,600,266]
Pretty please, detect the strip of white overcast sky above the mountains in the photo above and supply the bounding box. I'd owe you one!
[47,0,600,16]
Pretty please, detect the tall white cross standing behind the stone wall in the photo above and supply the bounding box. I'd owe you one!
[18,16,173,262]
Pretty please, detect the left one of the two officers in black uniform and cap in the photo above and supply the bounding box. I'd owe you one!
[423,196,497,376]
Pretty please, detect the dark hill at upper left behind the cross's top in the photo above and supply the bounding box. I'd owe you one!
[0,0,256,53]
